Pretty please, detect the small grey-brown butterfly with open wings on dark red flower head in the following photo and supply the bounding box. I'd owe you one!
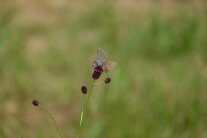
[92,48,117,72]
